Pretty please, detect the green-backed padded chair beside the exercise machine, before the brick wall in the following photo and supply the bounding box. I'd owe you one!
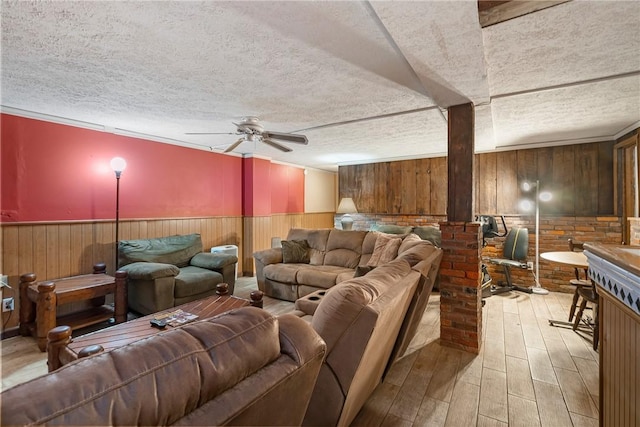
[489,227,532,295]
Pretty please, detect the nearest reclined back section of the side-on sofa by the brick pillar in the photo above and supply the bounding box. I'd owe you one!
[304,259,420,425]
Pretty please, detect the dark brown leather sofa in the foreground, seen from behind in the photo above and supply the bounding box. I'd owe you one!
[0,307,326,426]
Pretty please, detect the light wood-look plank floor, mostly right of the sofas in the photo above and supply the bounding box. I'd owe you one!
[1,278,598,427]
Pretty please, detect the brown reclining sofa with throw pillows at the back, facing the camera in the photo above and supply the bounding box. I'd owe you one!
[253,227,440,301]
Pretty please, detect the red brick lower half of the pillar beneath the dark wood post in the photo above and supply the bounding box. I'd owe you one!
[440,221,482,354]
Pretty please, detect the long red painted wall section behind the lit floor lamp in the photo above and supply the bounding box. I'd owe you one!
[0,114,244,222]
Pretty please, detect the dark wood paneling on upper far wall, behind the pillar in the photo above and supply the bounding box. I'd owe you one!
[338,142,614,216]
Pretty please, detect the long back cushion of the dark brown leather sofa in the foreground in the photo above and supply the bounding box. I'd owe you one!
[2,307,281,425]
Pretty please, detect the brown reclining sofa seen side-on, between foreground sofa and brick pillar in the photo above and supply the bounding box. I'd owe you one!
[296,241,442,426]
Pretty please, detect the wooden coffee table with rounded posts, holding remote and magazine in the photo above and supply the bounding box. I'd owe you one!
[47,283,263,372]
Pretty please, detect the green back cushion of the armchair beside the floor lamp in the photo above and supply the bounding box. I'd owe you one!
[118,234,202,267]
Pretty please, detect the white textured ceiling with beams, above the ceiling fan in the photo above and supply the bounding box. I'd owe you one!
[1,0,640,170]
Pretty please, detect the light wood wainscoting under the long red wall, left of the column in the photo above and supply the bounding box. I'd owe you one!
[1,217,243,332]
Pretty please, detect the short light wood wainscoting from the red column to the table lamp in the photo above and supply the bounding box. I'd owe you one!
[241,212,335,276]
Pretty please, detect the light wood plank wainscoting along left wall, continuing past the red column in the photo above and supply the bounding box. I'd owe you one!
[0,212,334,331]
